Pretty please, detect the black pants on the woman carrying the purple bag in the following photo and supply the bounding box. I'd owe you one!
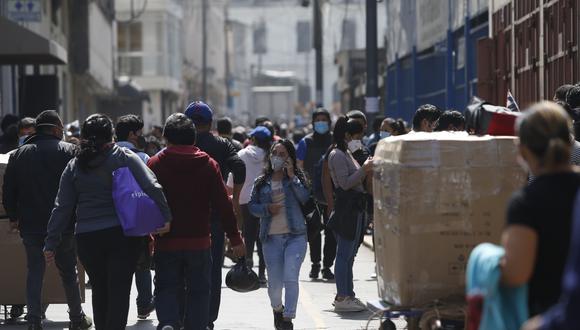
[77,227,141,330]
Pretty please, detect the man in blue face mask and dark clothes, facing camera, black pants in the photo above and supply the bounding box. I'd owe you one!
[296,108,336,280]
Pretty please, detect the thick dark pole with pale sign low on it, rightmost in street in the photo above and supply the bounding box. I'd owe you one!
[365,0,379,117]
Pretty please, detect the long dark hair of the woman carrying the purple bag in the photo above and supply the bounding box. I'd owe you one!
[77,113,114,170]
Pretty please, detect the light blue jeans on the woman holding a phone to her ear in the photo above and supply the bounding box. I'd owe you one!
[262,234,307,319]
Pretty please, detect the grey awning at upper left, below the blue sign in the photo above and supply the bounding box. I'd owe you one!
[0,16,67,65]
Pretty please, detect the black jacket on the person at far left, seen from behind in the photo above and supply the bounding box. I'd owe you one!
[2,134,76,235]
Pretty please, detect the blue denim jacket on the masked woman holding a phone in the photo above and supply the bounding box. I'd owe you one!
[248,176,310,241]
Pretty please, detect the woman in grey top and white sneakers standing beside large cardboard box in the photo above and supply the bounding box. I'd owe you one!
[328,117,373,312]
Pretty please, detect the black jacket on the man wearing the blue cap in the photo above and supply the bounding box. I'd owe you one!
[195,132,246,184]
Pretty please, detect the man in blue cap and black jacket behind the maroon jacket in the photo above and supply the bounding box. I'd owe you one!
[185,102,246,329]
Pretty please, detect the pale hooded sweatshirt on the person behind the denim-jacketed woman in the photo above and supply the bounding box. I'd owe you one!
[228,145,266,205]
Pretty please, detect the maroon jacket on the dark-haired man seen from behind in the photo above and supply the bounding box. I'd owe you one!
[147,146,242,251]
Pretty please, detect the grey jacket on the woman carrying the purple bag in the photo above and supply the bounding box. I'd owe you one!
[45,145,171,250]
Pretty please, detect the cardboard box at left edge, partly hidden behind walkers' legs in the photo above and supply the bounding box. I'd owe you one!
[0,219,85,305]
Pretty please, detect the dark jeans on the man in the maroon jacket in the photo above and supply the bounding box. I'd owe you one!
[155,249,212,330]
